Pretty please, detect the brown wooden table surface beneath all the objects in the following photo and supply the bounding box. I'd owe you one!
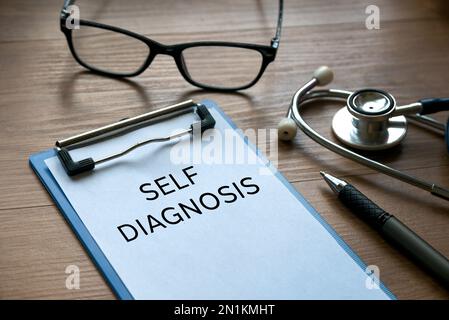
[0,0,449,299]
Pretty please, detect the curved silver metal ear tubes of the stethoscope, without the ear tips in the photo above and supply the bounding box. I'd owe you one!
[287,86,449,200]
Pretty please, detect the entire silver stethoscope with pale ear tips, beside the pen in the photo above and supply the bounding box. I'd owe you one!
[278,66,449,200]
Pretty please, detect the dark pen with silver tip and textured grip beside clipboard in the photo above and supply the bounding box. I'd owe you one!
[320,171,449,288]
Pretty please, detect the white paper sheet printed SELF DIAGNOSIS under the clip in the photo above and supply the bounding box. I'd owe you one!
[46,105,389,299]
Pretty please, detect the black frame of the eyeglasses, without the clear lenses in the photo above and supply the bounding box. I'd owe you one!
[60,0,284,91]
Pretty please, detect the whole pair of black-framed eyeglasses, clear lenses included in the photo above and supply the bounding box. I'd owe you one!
[60,0,283,91]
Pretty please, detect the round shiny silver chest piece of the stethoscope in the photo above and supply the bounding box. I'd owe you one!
[332,89,407,150]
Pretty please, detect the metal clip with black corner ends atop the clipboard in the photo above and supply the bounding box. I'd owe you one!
[56,100,215,176]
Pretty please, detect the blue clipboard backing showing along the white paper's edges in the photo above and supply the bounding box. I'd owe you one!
[29,100,396,300]
